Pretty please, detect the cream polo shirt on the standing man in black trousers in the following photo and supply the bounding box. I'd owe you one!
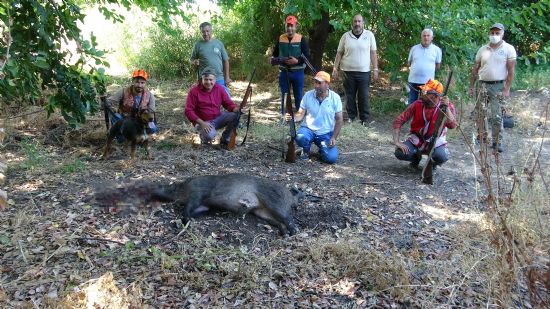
[338,29,376,72]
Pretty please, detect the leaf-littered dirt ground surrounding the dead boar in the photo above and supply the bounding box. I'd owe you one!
[0,83,550,308]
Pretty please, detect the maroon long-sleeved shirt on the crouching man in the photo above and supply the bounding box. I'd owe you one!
[185,84,236,124]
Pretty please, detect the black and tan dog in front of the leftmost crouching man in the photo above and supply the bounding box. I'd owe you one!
[102,109,153,161]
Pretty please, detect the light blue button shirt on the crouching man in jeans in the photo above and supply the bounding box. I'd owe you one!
[300,89,342,135]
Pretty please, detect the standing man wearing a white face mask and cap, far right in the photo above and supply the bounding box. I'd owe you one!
[468,23,516,152]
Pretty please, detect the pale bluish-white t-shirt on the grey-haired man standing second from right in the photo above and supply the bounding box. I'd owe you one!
[408,44,441,84]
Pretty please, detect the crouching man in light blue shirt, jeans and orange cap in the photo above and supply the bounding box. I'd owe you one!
[286,71,344,164]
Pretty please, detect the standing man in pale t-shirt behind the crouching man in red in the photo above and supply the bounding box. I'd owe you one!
[408,28,441,104]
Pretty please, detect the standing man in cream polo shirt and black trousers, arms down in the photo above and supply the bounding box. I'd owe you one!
[332,14,378,125]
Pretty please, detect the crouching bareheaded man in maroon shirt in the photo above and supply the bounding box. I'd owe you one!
[185,67,243,149]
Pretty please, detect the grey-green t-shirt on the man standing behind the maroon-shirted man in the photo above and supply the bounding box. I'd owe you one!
[191,39,229,80]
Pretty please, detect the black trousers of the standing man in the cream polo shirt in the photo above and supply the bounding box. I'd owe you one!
[344,71,376,121]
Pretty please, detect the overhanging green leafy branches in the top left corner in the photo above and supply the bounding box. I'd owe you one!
[0,0,107,126]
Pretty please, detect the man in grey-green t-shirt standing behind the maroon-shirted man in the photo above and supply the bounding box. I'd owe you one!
[191,22,231,94]
